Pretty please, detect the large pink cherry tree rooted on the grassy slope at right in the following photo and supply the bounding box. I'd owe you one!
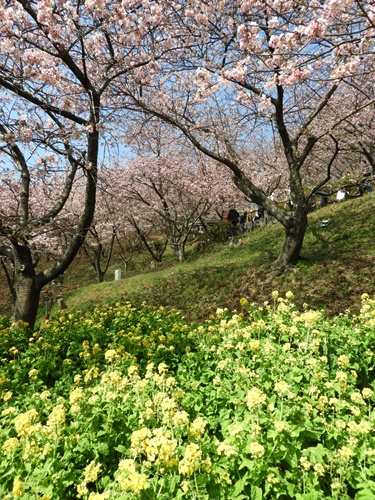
[119,0,375,271]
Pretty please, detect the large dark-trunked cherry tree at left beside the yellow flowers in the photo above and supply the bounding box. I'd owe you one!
[0,0,173,327]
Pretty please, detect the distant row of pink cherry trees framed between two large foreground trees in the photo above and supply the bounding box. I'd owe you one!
[59,143,246,282]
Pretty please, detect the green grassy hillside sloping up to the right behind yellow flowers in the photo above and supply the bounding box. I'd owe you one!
[1,191,375,320]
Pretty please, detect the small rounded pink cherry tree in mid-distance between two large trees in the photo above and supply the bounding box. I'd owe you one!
[108,150,239,262]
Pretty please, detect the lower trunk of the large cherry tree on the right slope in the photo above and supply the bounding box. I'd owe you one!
[273,213,307,273]
